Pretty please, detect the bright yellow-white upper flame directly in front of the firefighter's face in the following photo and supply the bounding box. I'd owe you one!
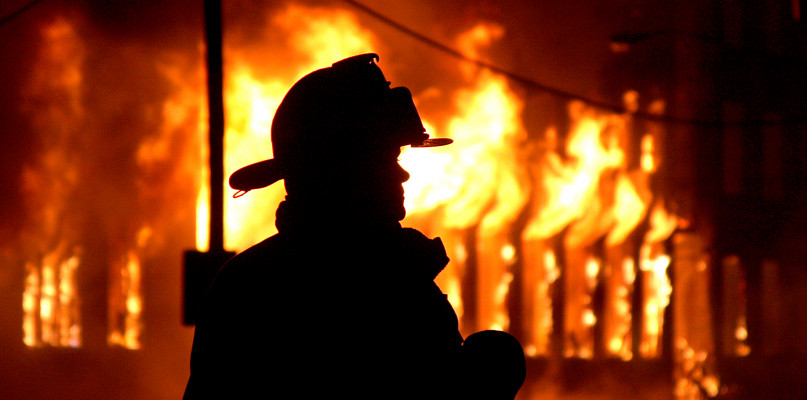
[401,66,527,228]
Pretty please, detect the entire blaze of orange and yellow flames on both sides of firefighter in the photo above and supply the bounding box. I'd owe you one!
[9,4,750,396]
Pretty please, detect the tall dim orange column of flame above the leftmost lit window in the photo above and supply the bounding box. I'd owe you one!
[22,19,85,347]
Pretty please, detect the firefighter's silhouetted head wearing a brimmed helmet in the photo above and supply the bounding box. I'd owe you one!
[230,54,451,225]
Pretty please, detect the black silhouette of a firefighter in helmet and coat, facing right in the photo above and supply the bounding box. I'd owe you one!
[185,54,525,399]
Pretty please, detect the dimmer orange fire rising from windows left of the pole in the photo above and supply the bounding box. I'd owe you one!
[21,18,200,348]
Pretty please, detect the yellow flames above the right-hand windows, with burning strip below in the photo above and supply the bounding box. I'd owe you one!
[522,101,636,358]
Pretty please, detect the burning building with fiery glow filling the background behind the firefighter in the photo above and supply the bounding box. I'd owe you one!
[0,0,807,400]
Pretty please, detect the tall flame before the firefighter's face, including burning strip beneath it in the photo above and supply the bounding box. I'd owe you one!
[401,24,529,330]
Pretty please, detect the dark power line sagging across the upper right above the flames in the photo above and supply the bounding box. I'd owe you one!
[342,0,807,126]
